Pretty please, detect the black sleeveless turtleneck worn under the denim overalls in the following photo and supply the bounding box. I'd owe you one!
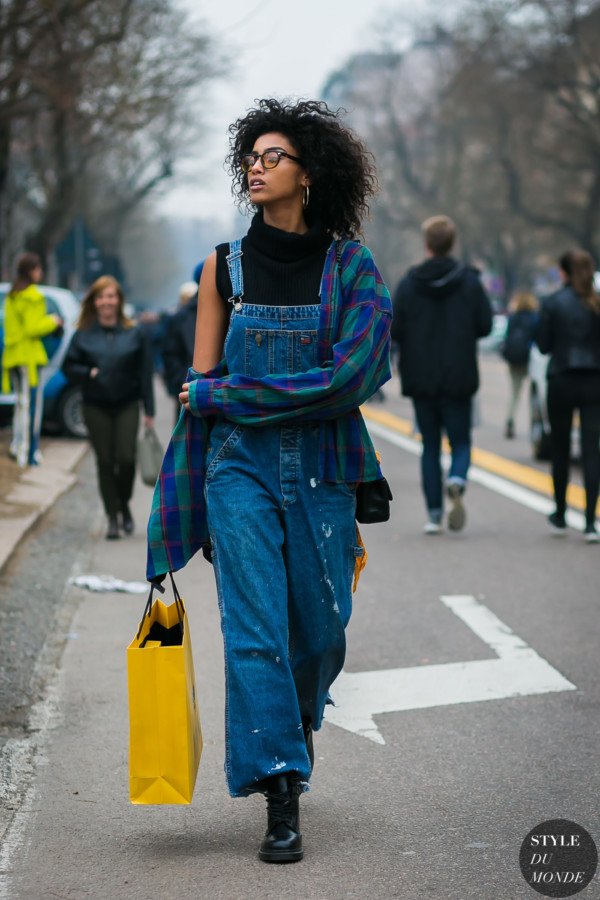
[216,212,331,313]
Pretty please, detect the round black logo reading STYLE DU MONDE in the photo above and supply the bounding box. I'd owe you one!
[519,819,598,897]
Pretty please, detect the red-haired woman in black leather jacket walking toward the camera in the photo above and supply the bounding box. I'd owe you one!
[62,275,154,540]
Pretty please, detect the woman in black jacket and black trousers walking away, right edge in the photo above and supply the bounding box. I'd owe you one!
[537,250,600,543]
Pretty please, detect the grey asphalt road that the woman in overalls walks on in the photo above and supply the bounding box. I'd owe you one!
[0,359,600,900]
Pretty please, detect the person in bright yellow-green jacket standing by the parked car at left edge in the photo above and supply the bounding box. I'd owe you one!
[2,253,63,467]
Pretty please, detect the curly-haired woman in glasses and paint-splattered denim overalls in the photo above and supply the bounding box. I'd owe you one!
[172,100,391,862]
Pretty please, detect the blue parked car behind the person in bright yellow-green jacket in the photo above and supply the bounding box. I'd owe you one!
[0,282,86,438]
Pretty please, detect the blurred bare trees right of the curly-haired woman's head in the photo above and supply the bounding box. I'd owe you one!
[326,0,600,292]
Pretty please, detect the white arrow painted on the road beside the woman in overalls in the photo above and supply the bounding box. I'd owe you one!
[326,596,577,744]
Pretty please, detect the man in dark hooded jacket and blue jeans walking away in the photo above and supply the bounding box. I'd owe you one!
[392,216,492,534]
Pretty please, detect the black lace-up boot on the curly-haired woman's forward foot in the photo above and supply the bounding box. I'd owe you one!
[258,772,304,862]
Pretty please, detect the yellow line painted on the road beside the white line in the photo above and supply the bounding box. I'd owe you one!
[361,406,600,511]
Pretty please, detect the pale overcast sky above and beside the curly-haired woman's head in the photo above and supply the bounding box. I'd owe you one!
[159,0,438,220]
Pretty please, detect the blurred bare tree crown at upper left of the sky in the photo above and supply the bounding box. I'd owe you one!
[0,0,220,274]
